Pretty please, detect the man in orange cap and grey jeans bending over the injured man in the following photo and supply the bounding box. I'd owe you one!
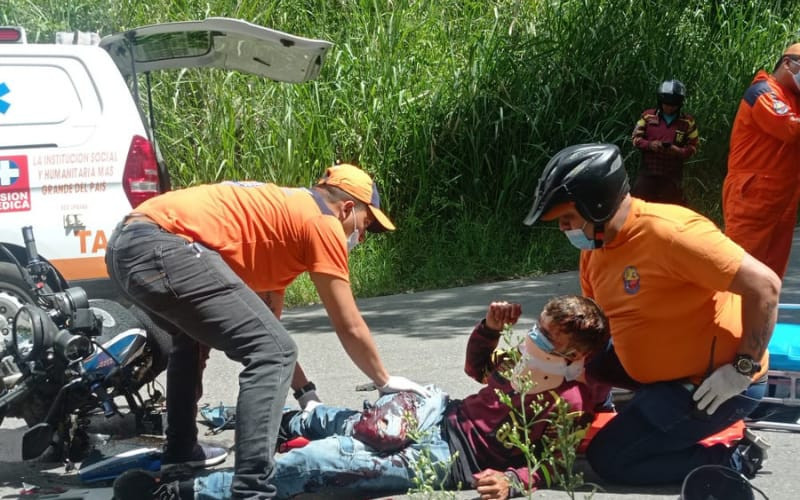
[106,164,428,499]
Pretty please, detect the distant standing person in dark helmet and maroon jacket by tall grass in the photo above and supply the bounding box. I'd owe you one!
[631,80,699,205]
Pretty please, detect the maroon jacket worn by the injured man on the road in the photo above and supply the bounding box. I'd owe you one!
[445,321,597,488]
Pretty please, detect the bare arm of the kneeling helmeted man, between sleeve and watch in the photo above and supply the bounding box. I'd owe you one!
[728,254,781,360]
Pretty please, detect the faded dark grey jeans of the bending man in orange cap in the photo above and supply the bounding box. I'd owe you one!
[106,222,297,498]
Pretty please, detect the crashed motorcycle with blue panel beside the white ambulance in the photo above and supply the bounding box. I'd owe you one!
[0,226,171,462]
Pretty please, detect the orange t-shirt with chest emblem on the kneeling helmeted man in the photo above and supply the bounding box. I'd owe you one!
[580,198,768,383]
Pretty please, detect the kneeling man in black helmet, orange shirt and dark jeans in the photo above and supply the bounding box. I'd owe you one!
[525,144,781,485]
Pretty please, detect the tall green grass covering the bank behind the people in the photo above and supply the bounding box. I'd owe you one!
[0,0,800,303]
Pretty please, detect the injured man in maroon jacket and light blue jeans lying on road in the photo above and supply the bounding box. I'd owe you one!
[114,296,609,500]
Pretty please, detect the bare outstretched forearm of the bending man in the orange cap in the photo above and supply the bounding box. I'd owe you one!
[310,273,389,387]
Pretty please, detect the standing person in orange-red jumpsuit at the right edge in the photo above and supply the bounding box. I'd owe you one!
[722,43,800,277]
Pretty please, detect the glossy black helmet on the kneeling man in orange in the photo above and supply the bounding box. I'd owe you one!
[523,144,629,226]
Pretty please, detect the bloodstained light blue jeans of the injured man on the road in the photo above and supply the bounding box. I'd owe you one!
[188,386,450,500]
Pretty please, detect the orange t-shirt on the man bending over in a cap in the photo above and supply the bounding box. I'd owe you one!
[136,182,350,292]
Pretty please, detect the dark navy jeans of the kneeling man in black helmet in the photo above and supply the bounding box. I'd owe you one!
[586,382,766,485]
